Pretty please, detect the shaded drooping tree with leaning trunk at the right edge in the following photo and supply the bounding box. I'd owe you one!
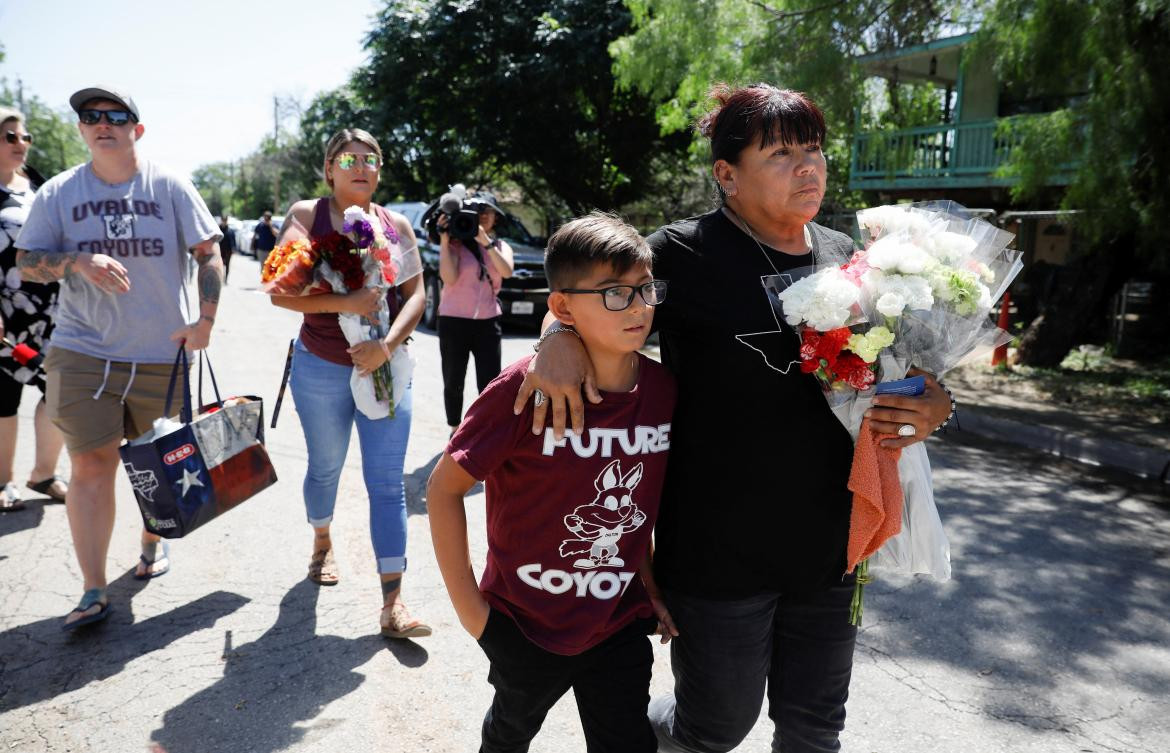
[980,0,1170,366]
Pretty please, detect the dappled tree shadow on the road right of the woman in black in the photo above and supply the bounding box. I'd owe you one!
[858,442,1170,730]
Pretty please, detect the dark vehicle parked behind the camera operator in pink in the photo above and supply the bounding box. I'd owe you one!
[386,201,549,330]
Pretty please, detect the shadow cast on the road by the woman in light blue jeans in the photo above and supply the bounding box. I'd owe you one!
[151,580,428,753]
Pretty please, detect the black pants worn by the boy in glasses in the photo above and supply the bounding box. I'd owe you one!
[480,609,658,753]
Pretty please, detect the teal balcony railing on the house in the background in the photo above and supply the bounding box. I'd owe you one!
[849,116,1062,189]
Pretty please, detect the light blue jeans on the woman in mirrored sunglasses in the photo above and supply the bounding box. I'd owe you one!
[289,340,411,573]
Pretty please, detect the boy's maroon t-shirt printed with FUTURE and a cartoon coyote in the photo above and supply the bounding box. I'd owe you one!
[447,355,675,655]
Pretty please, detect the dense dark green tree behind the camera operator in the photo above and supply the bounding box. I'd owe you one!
[343,0,689,213]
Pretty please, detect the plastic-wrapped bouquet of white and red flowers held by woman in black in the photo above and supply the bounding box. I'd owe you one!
[764,201,1023,596]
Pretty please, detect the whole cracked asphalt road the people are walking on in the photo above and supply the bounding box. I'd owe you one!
[0,257,1170,753]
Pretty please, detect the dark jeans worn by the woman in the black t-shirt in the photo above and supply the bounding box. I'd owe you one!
[649,575,858,753]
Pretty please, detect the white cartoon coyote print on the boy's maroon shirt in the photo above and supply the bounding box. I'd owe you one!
[560,461,646,569]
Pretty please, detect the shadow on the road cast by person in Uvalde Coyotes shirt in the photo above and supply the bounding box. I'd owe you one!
[0,569,248,712]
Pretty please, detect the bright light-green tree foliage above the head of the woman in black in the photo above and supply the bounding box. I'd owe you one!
[611,0,969,209]
